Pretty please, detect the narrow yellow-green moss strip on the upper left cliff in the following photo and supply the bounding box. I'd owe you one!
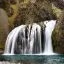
[8,0,18,30]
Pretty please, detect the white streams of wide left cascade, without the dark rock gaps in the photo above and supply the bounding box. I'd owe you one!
[4,23,42,55]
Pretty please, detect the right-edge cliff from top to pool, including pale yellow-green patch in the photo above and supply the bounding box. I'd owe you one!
[51,0,64,54]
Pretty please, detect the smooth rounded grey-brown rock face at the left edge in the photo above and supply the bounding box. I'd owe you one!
[0,9,8,52]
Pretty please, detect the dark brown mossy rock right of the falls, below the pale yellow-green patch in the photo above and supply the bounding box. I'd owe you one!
[52,12,64,54]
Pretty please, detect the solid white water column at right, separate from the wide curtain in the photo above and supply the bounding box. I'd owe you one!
[43,20,56,55]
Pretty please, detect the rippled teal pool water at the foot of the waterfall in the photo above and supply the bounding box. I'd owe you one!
[0,55,64,64]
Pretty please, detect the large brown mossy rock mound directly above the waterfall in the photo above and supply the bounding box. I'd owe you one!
[14,0,56,26]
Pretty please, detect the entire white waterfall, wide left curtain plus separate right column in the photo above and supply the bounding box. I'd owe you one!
[4,20,56,55]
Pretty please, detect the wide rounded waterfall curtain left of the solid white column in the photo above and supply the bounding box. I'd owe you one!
[4,23,42,55]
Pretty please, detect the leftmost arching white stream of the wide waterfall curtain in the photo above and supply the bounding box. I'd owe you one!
[4,25,25,55]
